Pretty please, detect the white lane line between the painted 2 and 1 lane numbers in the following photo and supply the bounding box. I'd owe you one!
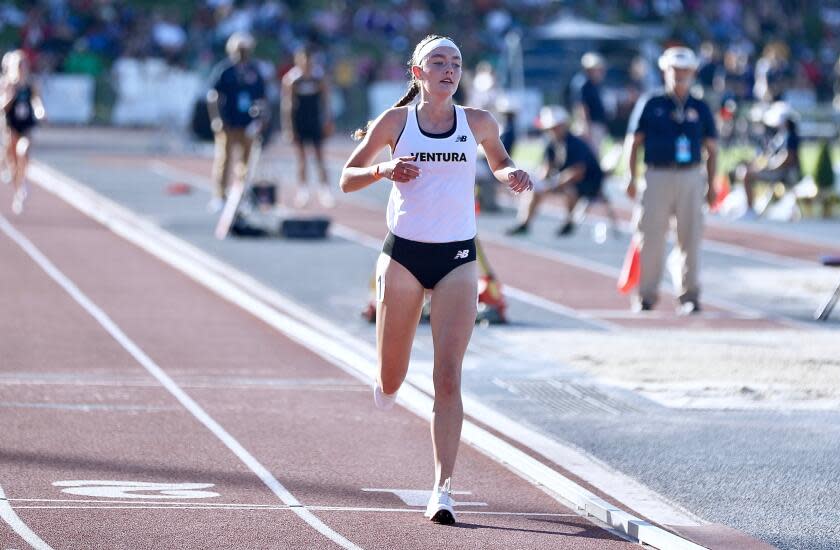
[0,215,359,549]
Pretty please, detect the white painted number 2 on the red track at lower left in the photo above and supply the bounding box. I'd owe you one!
[53,479,219,500]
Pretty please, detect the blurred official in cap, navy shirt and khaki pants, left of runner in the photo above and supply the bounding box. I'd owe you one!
[207,32,268,212]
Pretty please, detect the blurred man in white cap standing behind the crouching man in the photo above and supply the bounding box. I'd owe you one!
[573,52,607,155]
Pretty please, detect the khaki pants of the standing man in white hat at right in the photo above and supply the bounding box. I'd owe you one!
[634,168,706,305]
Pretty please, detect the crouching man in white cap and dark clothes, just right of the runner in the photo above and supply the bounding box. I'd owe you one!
[507,105,604,236]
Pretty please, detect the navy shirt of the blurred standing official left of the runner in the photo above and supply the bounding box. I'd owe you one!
[212,61,265,128]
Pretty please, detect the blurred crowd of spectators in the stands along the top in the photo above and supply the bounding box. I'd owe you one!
[0,0,840,125]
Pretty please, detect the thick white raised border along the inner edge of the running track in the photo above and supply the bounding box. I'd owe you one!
[29,163,703,550]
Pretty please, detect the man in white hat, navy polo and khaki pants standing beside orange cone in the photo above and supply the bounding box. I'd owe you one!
[627,47,717,314]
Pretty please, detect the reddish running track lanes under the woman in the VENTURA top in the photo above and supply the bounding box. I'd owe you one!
[0,183,634,549]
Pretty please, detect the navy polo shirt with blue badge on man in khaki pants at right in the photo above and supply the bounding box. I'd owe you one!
[627,90,717,166]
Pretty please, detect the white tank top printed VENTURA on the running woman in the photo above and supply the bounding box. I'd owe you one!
[387,105,478,243]
